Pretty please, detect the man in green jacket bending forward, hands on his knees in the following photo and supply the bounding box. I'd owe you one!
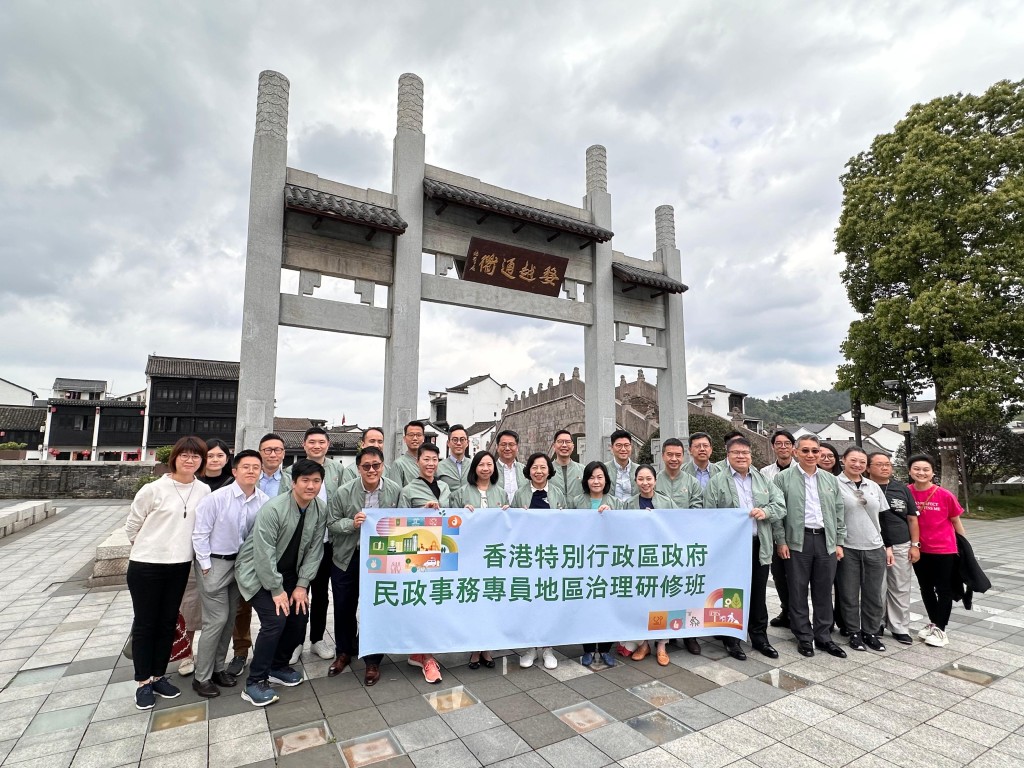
[234,459,327,707]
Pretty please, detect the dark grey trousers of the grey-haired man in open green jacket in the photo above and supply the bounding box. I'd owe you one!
[786,530,836,643]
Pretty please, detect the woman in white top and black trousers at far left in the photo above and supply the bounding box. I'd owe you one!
[125,437,210,710]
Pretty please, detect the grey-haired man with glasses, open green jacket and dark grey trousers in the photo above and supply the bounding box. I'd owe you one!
[773,435,846,658]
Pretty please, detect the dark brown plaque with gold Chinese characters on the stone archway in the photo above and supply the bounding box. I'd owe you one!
[462,238,569,297]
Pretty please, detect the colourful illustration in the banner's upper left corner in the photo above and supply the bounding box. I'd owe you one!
[367,515,462,573]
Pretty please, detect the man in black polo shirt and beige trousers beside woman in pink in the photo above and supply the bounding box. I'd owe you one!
[867,452,921,645]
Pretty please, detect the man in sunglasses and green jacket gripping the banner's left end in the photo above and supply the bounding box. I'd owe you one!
[327,444,401,686]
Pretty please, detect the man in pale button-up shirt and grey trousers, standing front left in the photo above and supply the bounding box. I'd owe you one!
[193,451,269,698]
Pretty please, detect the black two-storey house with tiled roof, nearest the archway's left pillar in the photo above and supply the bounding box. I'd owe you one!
[141,354,239,459]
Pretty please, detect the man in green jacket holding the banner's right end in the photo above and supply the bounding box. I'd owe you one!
[705,437,785,658]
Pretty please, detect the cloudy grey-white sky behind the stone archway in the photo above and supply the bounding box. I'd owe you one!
[0,0,1024,424]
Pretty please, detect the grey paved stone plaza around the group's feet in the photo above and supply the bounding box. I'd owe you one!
[0,502,1024,768]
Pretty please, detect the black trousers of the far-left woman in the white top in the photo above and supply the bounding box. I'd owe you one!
[128,560,191,681]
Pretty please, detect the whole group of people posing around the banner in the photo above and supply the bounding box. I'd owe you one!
[126,421,963,710]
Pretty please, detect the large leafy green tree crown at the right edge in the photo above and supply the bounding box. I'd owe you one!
[836,81,1024,493]
